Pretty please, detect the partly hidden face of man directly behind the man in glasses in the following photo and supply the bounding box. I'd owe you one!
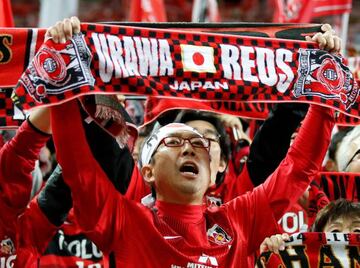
[186,120,226,186]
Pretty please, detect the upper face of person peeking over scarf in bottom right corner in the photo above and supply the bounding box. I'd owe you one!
[324,216,360,233]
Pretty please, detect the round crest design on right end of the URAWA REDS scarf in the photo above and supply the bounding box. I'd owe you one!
[293,49,359,110]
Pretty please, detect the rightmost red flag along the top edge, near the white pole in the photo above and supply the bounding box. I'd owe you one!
[312,0,352,17]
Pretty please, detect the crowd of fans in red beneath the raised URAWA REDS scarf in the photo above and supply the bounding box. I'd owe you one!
[0,18,360,267]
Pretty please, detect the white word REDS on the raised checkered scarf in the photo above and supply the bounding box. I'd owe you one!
[220,44,294,93]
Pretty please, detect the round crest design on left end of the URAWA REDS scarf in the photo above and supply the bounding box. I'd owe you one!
[19,34,95,102]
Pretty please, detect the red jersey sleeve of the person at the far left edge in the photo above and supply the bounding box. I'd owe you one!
[0,121,50,267]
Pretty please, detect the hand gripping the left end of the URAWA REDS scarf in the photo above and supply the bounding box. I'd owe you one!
[45,17,80,43]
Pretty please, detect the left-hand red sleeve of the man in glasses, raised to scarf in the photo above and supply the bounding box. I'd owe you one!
[51,100,124,253]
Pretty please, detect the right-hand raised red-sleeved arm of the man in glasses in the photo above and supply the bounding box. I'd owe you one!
[260,105,335,220]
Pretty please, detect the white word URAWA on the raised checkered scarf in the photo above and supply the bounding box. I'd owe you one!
[91,33,174,83]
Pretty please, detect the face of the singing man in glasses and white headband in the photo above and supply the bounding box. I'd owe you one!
[142,131,210,204]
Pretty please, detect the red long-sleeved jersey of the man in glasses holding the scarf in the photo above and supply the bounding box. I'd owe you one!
[52,101,334,267]
